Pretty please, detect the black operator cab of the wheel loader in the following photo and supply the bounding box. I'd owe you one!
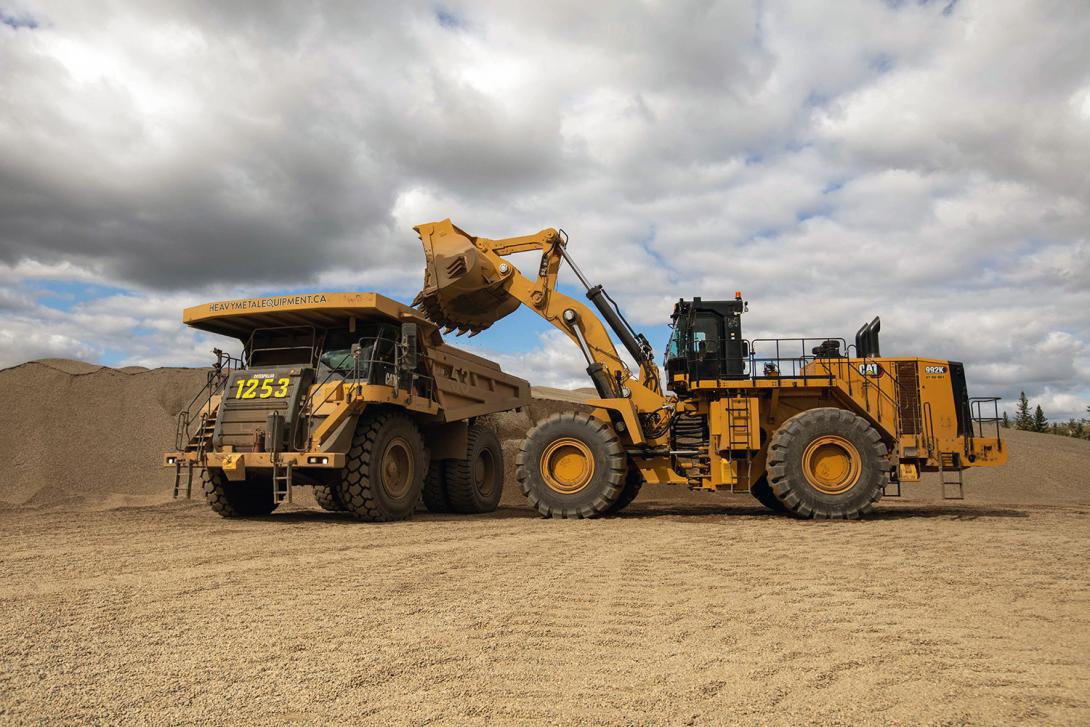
[666,293,749,380]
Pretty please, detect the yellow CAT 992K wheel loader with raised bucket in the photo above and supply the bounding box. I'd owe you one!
[414,219,1007,518]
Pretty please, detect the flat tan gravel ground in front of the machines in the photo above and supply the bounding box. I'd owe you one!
[0,489,1090,725]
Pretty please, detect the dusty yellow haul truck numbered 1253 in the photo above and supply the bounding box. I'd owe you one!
[164,293,530,521]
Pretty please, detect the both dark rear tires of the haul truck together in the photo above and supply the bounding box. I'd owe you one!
[423,424,504,514]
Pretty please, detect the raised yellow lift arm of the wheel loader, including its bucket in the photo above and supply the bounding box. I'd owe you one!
[414,219,673,446]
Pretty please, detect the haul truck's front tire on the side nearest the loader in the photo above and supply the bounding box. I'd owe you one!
[337,411,427,522]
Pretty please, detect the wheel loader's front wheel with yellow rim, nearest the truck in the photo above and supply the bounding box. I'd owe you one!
[516,412,628,518]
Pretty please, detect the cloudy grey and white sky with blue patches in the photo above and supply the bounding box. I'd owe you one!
[0,0,1090,419]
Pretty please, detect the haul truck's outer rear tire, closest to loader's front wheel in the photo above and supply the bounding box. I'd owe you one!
[446,424,504,514]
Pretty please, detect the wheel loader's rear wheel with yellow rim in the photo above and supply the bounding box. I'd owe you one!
[768,408,889,519]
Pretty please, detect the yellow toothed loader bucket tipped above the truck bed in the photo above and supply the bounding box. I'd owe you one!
[413,219,519,335]
